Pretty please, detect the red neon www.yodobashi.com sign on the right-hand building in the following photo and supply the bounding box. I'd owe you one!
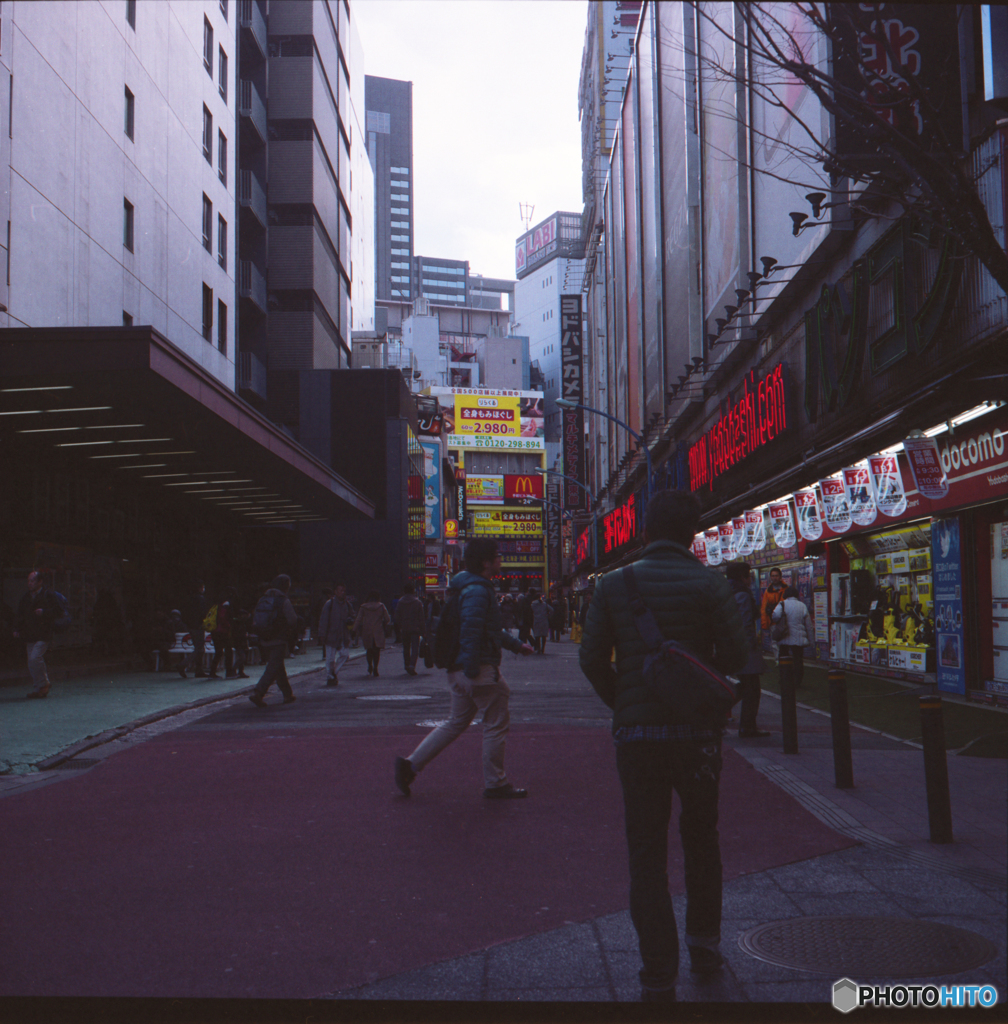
[689,362,789,490]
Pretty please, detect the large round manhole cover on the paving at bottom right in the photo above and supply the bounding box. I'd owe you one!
[739,918,998,978]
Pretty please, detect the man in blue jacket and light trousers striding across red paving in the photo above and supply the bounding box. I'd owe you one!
[394,537,532,800]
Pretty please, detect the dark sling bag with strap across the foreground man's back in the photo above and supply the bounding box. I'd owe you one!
[623,565,737,731]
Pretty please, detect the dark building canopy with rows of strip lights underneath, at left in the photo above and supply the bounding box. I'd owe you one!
[0,328,374,526]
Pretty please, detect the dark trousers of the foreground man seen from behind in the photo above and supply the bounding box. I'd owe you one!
[616,738,721,988]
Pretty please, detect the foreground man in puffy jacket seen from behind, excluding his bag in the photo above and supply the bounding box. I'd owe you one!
[580,490,749,1000]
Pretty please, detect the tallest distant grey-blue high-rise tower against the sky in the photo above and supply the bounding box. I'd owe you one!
[364,75,416,301]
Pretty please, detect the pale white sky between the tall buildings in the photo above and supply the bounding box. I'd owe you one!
[350,0,588,279]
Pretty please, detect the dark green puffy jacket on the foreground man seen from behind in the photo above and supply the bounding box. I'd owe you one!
[579,541,750,732]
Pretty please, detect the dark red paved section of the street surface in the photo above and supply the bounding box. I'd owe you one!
[0,725,850,998]
